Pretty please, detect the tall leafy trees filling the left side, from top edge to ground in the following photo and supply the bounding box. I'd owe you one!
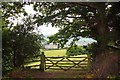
[1,2,43,75]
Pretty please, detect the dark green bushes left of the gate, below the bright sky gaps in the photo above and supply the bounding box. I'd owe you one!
[2,22,42,74]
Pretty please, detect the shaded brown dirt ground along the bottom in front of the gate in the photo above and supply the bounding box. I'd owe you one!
[8,70,85,78]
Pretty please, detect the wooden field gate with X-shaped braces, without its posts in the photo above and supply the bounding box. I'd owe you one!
[45,57,88,71]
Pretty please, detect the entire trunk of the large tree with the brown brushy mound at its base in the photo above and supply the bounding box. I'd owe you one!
[92,6,118,78]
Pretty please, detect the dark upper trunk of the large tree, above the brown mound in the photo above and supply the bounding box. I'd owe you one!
[96,6,109,53]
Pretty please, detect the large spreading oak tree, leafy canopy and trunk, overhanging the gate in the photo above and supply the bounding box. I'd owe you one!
[34,2,120,77]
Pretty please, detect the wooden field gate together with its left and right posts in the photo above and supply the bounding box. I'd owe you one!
[24,52,91,71]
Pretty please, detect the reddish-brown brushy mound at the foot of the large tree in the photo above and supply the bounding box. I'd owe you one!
[91,50,119,78]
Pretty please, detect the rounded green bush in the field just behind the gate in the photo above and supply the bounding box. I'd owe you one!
[66,45,87,56]
